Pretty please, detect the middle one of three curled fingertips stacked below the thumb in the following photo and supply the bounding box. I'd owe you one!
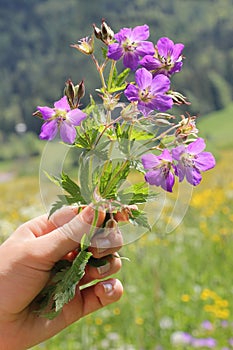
[80,253,122,285]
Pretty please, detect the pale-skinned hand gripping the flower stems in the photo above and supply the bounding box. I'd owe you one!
[0,207,123,350]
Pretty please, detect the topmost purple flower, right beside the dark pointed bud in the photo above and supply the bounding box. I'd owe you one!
[107,24,155,70]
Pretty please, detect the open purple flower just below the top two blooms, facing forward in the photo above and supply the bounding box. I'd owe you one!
[124,68,173,116]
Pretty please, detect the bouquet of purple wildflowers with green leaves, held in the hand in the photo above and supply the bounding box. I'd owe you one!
[34,20,215,318]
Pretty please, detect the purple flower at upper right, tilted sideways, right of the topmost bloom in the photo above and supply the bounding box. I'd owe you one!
[140,37,184,76]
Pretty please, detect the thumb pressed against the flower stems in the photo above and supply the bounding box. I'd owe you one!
[35,206,105,262]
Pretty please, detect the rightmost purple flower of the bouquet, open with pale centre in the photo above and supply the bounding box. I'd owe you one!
[172,138,215,186]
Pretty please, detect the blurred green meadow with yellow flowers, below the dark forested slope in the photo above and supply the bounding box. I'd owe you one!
[0,104,233,350]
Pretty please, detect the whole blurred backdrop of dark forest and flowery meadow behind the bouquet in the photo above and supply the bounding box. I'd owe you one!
[0,0,233,350]
